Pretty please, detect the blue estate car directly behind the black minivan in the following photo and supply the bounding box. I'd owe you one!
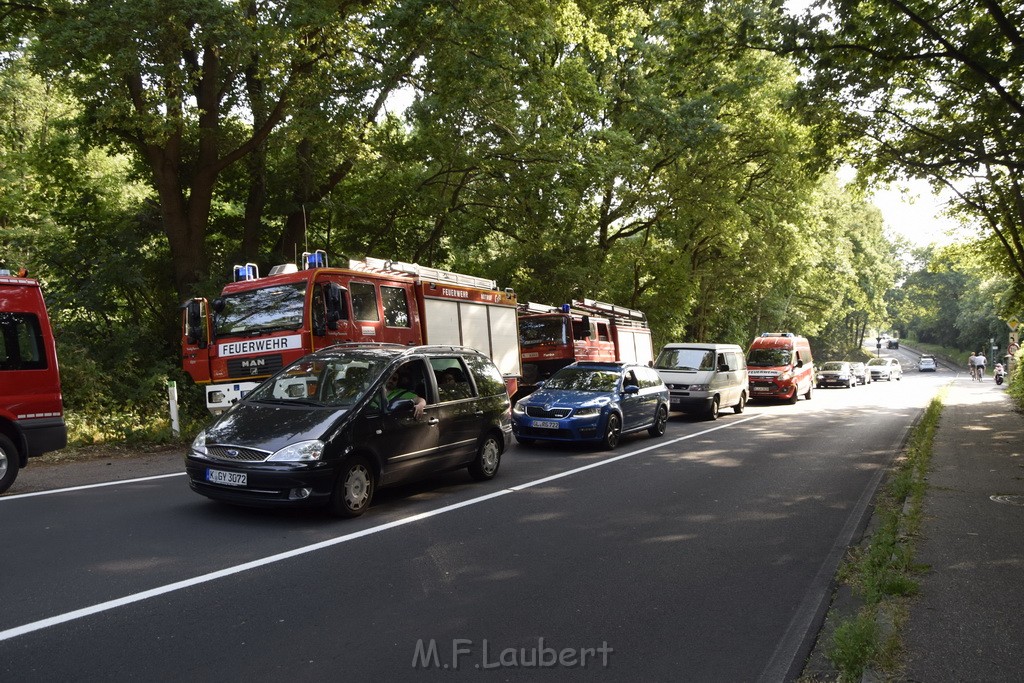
[512,362,669,449]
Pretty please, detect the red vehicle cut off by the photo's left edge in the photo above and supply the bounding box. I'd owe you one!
[0,269,68,494]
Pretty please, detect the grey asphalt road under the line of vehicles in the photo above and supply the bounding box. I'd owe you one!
[0,349,952,681]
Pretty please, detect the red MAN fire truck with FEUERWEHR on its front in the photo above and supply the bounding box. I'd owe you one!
[181,251,521,413]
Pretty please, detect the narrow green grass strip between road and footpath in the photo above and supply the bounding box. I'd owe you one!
[826,392,944,681]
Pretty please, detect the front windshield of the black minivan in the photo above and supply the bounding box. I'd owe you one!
[246,353,390,408]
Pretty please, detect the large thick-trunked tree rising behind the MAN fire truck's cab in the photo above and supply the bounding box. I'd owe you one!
[3,0,417,299]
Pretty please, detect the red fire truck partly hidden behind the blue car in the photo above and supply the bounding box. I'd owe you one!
[518,299,654,396]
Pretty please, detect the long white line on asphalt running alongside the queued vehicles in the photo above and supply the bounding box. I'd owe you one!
[0,415,760,642]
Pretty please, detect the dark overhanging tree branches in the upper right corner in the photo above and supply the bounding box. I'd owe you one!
[776,0,1024,290]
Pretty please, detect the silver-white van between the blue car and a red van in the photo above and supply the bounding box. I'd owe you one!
[654,343,748,420]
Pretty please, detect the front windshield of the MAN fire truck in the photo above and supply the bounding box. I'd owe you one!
[215,283,306,337]
